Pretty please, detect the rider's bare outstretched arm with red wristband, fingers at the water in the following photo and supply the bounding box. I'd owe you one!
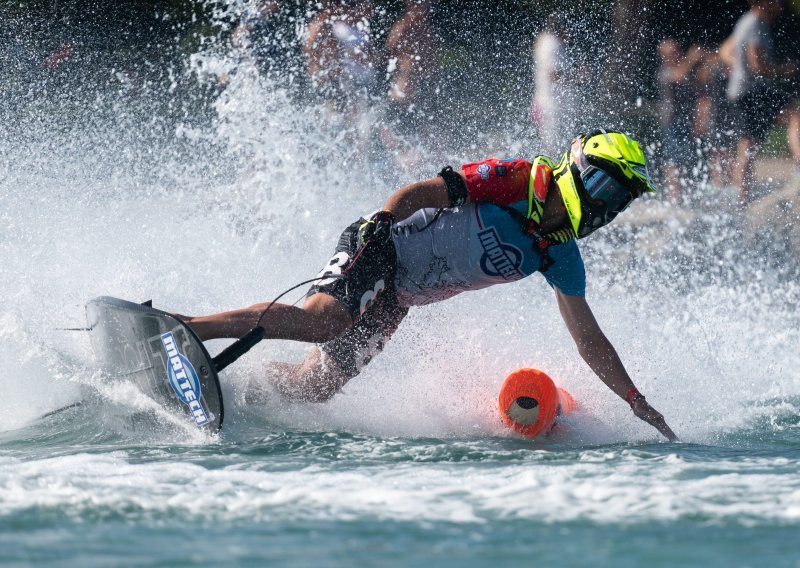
[556,290,677,441]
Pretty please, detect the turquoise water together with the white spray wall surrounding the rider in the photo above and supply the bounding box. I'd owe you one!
[0,10,800,566]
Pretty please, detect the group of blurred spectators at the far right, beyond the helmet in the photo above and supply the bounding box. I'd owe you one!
[658,0,800,204]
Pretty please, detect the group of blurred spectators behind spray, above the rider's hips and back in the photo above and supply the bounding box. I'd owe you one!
[233,0,441,178]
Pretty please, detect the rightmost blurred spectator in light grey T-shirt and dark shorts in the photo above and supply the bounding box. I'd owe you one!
[720,0,800,203]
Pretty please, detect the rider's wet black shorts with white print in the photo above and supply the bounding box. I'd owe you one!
[308,219,408,378]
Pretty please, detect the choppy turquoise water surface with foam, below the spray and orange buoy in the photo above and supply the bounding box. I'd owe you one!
[0,409,800,566]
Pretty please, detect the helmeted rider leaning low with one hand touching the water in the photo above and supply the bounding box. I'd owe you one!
[184,130,675,440]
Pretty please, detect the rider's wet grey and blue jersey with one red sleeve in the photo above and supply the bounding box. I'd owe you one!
[392,156,586,307]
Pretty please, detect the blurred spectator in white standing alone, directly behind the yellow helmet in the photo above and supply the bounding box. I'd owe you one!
[531,11,585,155]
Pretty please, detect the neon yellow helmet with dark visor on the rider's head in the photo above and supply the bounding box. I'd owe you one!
[553,129,656,239]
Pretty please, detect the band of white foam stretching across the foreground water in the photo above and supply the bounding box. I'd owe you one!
[0,450,800,526]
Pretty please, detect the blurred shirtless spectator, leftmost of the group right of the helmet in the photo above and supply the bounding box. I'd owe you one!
[658,39,703,201]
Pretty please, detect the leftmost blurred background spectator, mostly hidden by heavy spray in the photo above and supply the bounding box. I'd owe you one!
[232,0,305,84]
